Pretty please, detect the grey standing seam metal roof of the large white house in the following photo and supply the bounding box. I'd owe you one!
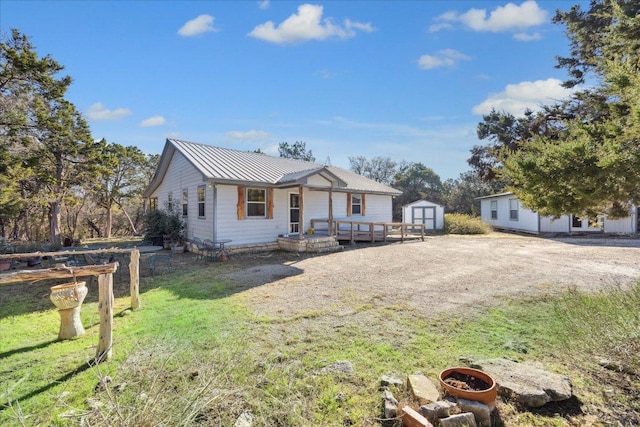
[145,139,402,195]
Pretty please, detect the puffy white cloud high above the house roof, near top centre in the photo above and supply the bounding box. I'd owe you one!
[248,4,375,44]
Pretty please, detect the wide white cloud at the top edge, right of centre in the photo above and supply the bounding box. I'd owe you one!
[429,0,548,33]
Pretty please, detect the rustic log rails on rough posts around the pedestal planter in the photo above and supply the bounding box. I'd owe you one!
[0,248,140,363]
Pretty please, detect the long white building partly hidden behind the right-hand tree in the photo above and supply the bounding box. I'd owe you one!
[477,192,638,234]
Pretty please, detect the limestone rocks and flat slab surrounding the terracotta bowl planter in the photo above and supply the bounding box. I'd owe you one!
[380,359,572,427]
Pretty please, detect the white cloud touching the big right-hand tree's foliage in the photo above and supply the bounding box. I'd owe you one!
[471,78,578,116]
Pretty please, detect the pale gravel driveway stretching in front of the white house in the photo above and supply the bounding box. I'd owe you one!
[227,233,640,317]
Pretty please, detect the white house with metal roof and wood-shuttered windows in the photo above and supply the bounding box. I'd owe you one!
[144,139,401,247]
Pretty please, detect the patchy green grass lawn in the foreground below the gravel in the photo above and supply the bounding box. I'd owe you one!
[0,264,640,426]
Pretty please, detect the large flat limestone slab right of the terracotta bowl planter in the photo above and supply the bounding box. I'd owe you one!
[472,359,572,408]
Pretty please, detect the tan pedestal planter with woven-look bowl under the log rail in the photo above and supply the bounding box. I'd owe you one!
[50,282,89,339]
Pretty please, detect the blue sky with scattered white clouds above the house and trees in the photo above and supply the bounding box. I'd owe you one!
[0,0,588,180]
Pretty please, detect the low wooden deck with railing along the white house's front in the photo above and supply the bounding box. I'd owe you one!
[310,219,424,243]
